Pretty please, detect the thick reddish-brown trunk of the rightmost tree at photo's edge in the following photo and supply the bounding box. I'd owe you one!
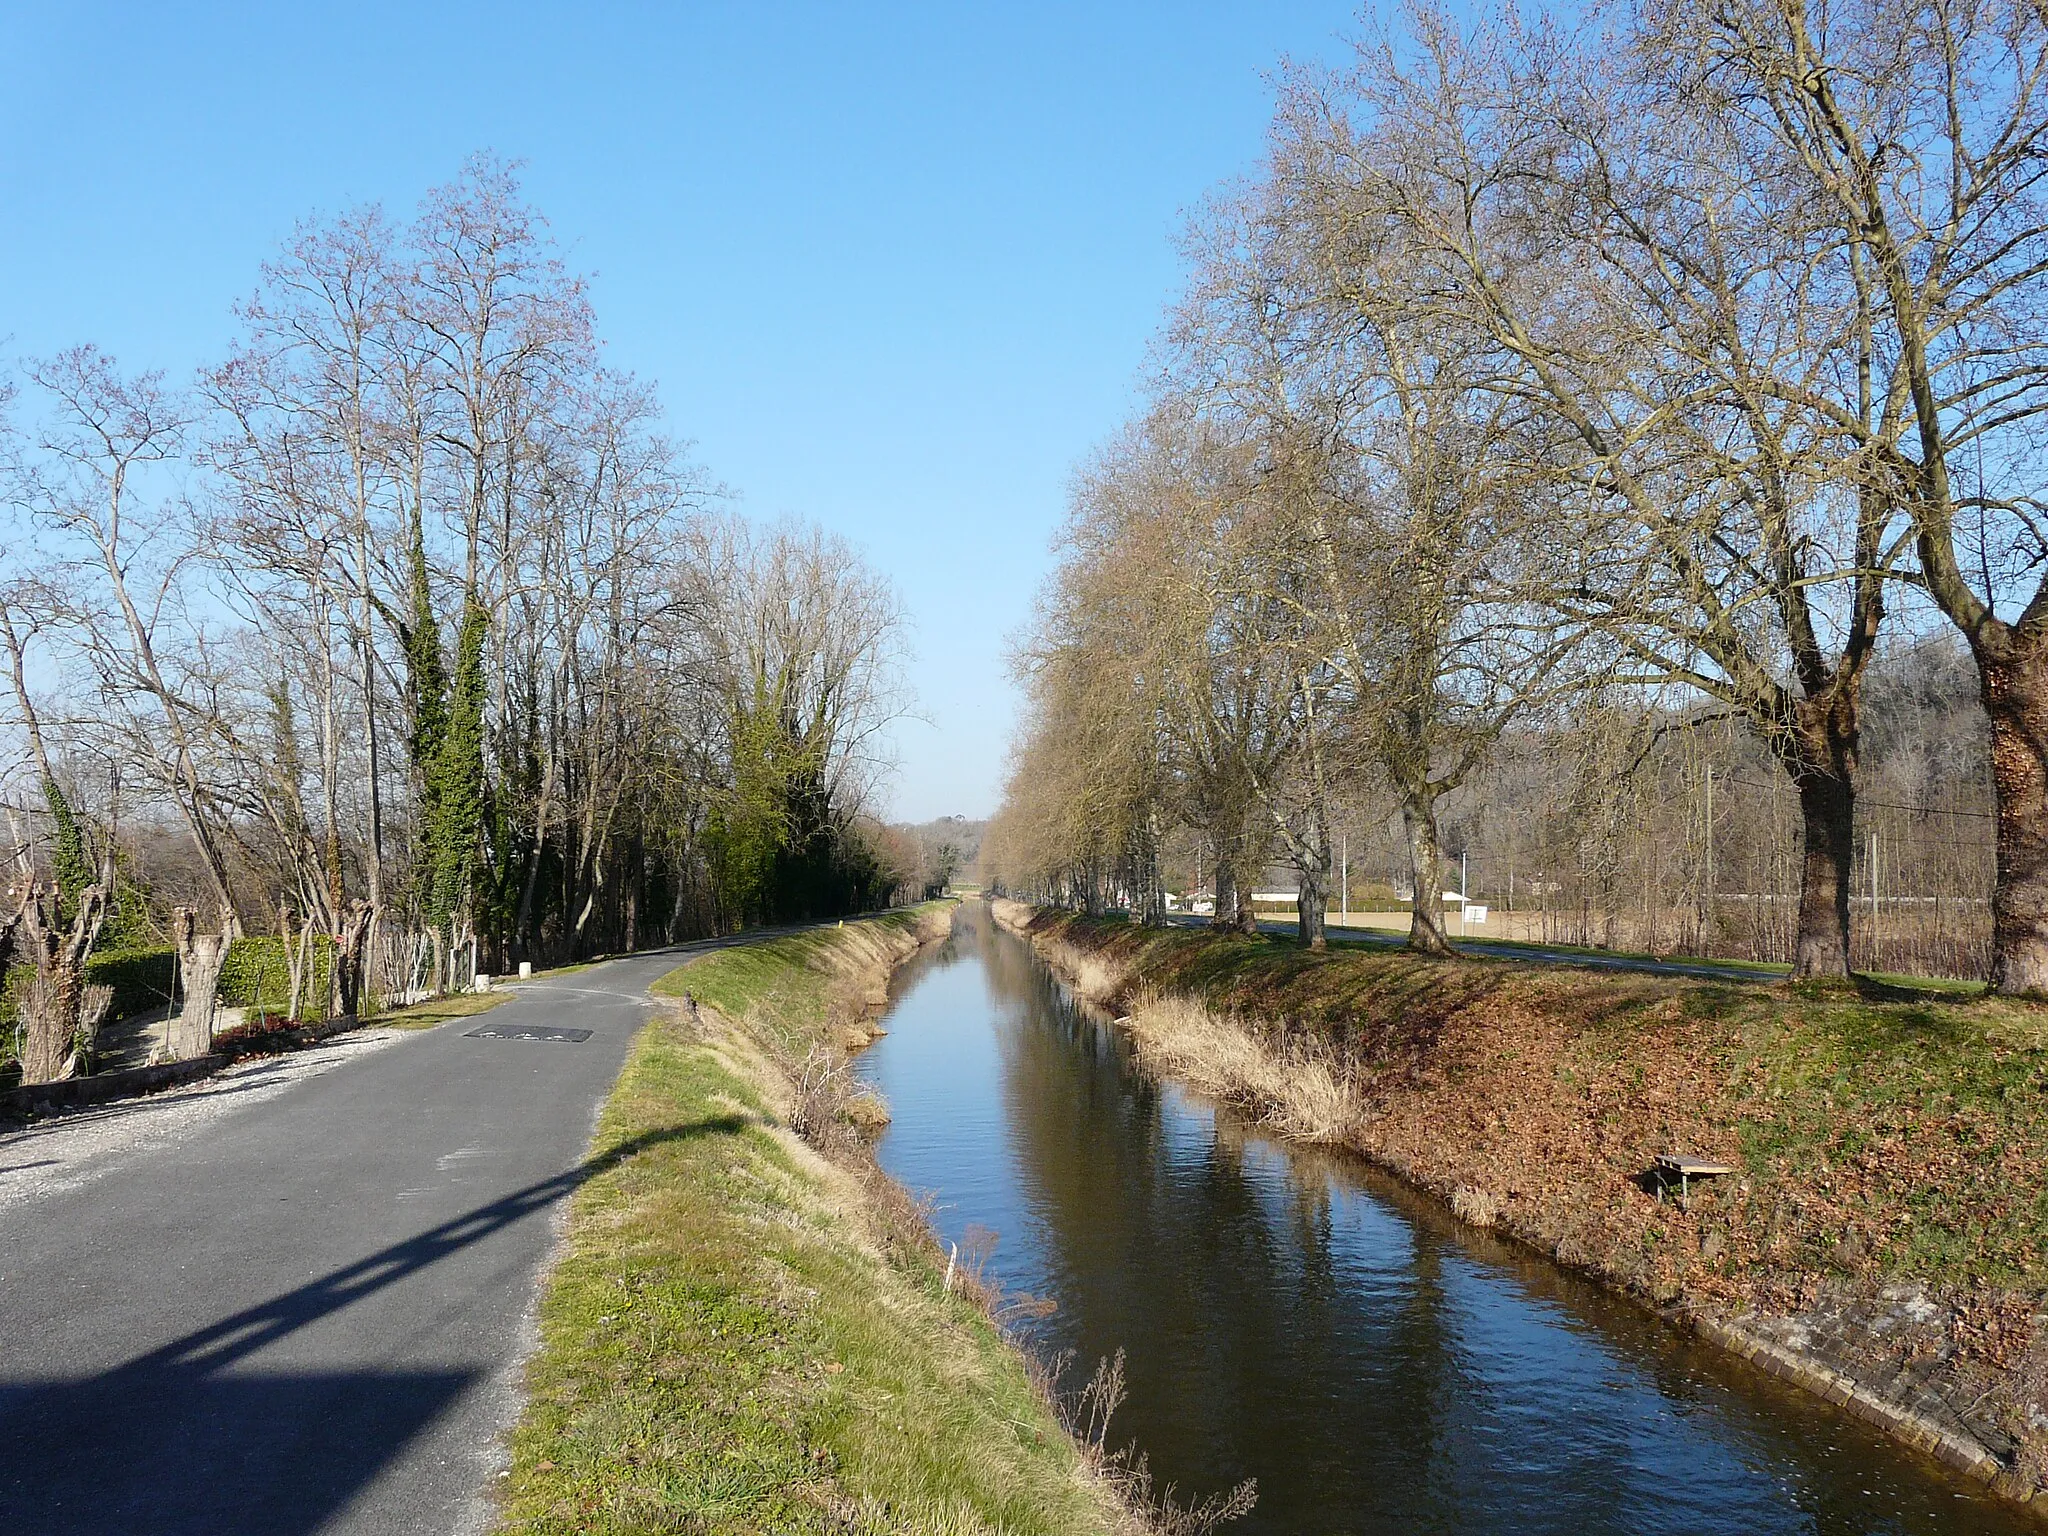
[1976,637,2048,993]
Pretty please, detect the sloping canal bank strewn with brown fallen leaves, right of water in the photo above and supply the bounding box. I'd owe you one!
[993,899,2048,1507]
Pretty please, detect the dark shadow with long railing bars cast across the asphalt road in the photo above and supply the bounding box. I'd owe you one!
[0,1116,752,1536]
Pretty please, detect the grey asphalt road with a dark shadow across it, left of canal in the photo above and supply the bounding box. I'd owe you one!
[0,950,704,1536]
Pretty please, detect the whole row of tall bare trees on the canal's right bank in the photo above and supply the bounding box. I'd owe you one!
[985,0,2048,991]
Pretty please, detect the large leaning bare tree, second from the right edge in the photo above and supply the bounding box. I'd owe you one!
[1284,10,1898,973]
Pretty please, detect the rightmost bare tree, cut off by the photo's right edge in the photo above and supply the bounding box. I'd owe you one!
[1645,0,2048,993]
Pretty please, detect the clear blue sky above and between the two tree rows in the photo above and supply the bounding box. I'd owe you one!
[0,0,1356,819]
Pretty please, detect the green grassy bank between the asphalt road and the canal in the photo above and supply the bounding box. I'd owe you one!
[502,911,1116,1536]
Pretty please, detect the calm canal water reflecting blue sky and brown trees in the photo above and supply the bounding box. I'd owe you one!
[860,903,2042,1536]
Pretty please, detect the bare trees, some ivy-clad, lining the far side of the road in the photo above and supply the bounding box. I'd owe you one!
[0,160,913,1081]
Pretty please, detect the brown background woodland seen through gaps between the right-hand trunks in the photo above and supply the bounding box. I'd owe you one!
[1122,635,1995,979]
